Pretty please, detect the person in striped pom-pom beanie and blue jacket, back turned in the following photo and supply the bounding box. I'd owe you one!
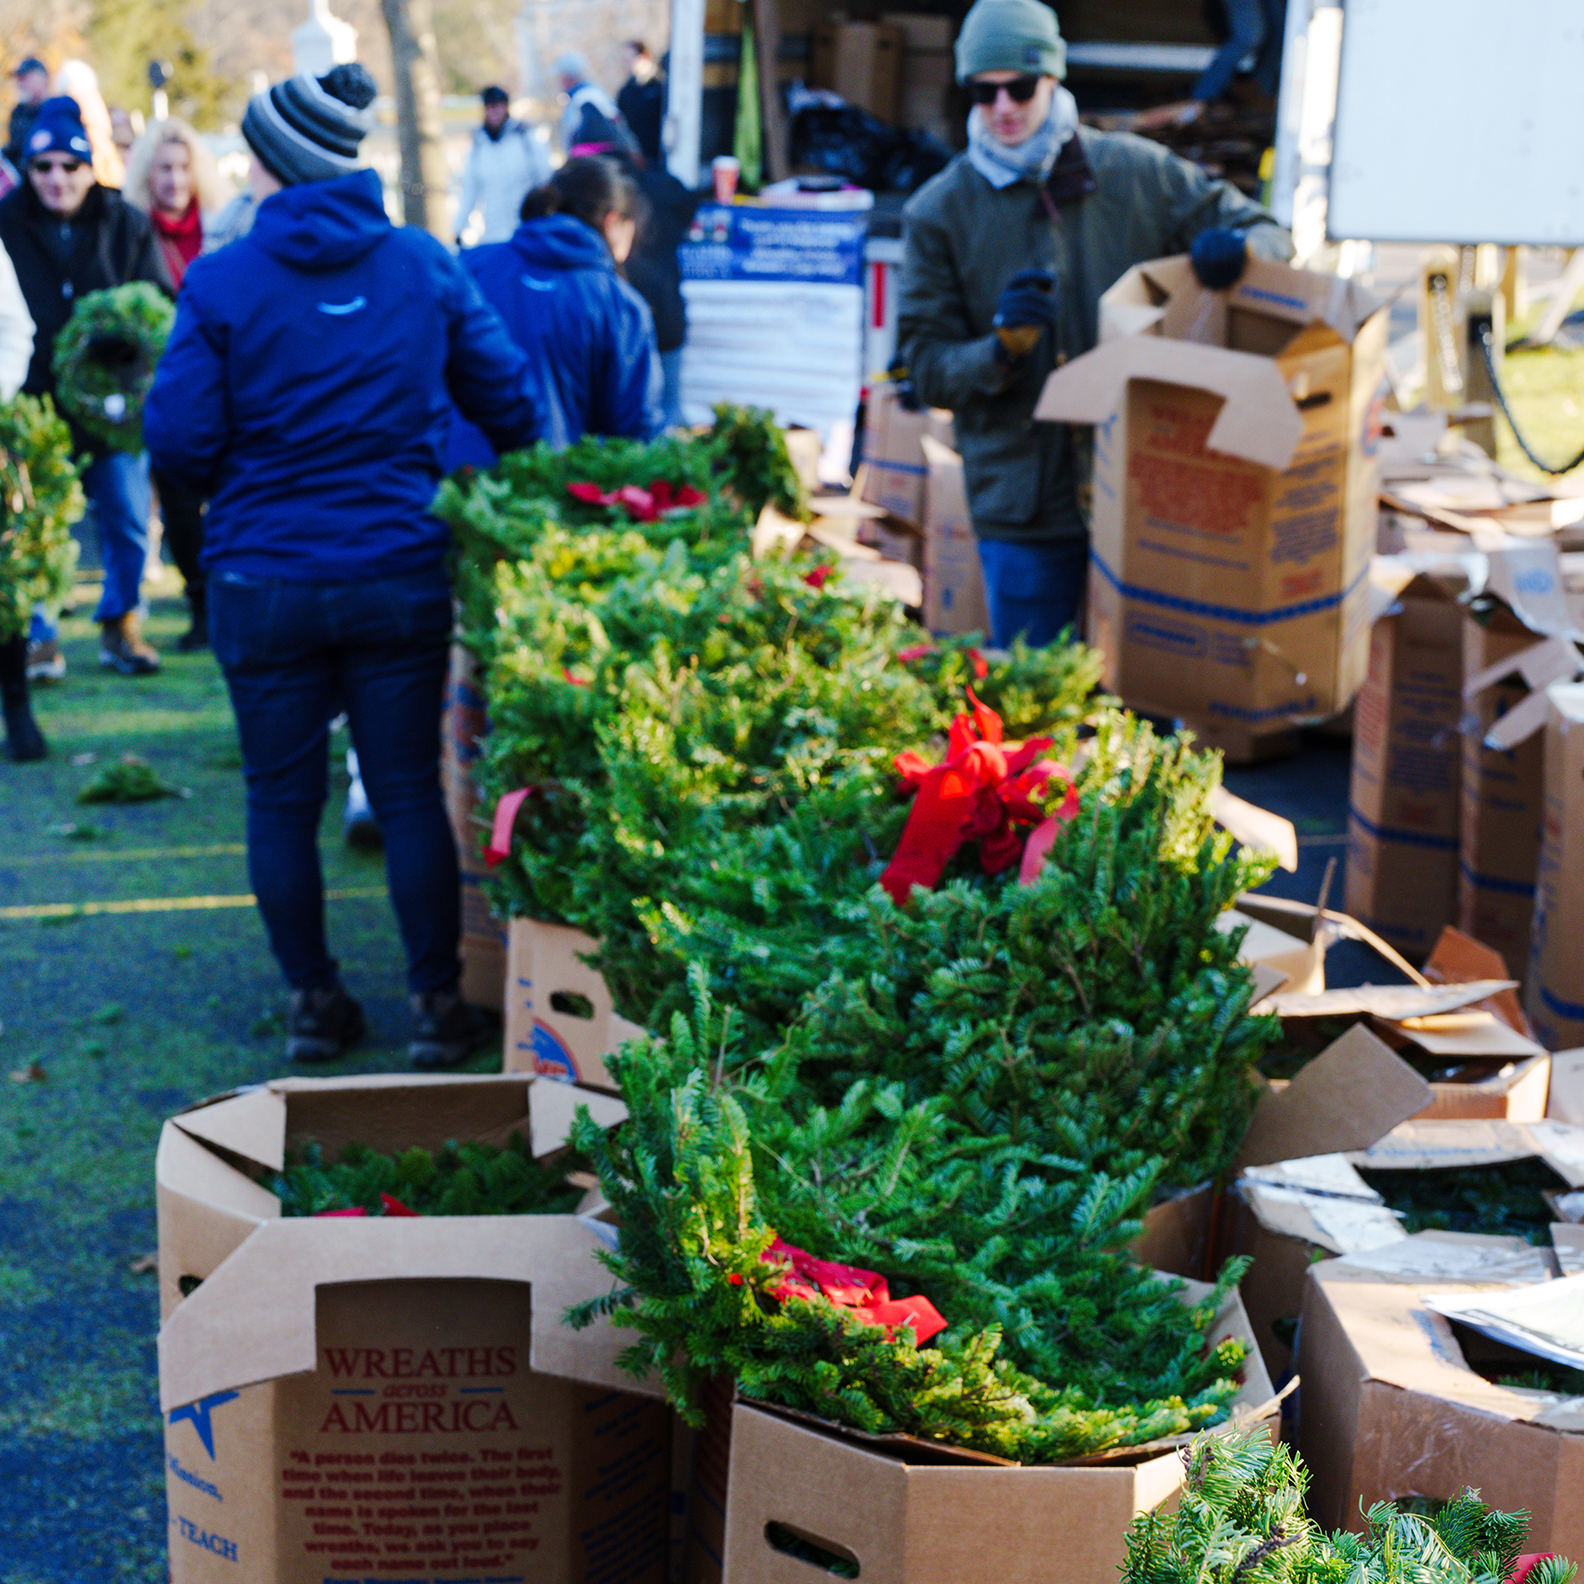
[144,65,542,1068]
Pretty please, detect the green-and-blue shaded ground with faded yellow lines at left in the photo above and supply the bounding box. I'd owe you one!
[0,563,499,1584]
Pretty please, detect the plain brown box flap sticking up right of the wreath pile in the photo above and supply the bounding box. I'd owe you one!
[1236,1025,1432,1166]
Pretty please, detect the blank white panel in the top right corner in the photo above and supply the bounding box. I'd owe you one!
[1327,0,1584,247]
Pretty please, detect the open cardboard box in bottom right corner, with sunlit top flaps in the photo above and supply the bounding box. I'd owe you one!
[1299,1232,1584,1555]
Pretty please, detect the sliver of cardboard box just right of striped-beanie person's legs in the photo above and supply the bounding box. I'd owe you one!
[440,643,505,1012]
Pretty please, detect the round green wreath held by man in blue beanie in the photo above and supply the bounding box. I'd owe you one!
[54,280,176,455]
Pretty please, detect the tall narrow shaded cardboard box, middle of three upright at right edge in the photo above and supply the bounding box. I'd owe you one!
[1457,605,1544,976]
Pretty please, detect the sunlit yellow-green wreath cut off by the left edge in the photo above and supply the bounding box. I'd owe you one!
[0,396,84,640]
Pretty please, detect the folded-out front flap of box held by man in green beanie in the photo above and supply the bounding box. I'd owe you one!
[1034,336,1304,470]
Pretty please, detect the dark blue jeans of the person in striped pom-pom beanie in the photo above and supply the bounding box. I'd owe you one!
[209,569,461,995]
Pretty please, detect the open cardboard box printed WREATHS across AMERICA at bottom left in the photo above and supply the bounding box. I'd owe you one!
[155,1077,670,1584]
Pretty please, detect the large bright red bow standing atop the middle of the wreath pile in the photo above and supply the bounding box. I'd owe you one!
[881,687,1079,906]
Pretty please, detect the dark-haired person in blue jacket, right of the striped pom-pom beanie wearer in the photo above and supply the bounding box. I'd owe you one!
[448,155,664,467]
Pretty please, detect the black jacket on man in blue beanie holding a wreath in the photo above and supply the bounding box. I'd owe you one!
[0,177,176,408]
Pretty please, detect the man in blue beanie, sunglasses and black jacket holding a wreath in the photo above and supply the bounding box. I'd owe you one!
[0,98,173,676]
